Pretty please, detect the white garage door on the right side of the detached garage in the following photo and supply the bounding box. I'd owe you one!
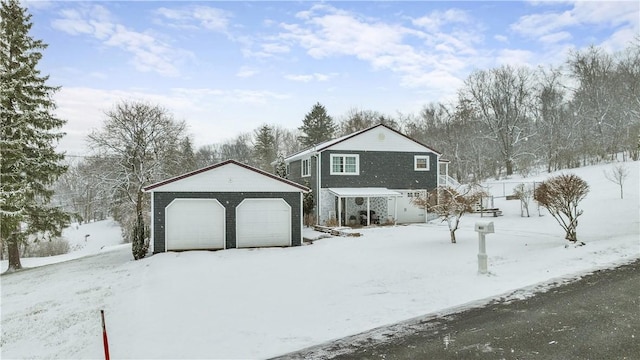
[236,199,291,248]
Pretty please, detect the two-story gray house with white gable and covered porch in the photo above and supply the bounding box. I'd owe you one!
[285,124,448,225]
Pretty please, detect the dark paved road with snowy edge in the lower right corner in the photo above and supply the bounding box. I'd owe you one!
[281,260,640,360]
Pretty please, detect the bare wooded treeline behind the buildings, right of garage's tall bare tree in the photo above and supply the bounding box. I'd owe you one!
[158,43,640,182]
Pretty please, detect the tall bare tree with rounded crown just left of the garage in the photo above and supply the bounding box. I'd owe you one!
[89,101,185,260]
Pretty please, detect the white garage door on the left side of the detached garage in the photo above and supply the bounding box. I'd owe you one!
[165,199,225,250]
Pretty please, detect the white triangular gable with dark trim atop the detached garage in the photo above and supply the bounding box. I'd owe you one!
[144,160,310,193]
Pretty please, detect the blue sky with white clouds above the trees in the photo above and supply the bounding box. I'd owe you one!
[25,1,640,154]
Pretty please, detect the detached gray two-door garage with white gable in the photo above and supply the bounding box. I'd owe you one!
[144,160,309,253]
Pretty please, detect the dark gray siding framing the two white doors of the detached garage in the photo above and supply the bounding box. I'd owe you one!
[153,192,302,253]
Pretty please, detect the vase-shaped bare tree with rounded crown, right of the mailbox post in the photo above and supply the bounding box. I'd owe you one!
[534,174,589,244]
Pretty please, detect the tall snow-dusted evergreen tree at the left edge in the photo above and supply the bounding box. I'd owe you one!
[0,0,69,270]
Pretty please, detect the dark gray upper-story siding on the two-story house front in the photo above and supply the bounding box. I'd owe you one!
[321,150,438,190]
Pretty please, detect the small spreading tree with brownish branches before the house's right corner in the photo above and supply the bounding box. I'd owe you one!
[412,185,487,244]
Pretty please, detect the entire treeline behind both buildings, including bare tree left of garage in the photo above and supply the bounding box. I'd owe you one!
[56,43,640,252]
